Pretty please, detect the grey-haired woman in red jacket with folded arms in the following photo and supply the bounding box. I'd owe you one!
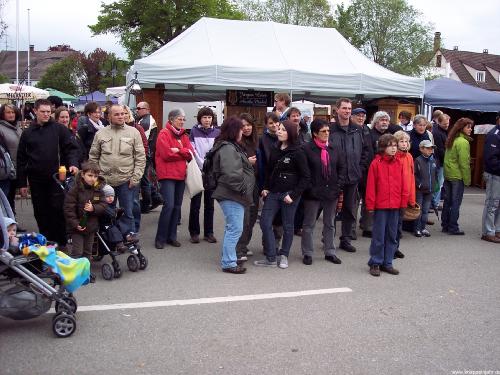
[155,109,194,249]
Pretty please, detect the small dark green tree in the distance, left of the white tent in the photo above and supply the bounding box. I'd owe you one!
[36,53,83,95]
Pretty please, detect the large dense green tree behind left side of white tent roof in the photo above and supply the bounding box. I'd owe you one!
[89,0,244,61]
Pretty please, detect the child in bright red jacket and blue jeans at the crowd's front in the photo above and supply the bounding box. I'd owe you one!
[365,134,408,276]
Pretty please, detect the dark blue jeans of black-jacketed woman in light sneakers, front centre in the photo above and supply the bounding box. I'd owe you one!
[260,193,300,262]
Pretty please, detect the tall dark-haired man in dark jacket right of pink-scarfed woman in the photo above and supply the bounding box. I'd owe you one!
[329,98,368,252]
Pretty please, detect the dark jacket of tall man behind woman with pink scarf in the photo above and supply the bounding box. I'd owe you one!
[328,123,369,185]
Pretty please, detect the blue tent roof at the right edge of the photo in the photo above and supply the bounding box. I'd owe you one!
[424,78,500,112]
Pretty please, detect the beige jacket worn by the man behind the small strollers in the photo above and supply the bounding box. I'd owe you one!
[89,124,146,186]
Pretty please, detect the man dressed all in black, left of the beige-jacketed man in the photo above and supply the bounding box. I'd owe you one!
[17,99,78,246]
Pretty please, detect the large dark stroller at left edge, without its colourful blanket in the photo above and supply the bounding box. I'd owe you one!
[0,191,82,337]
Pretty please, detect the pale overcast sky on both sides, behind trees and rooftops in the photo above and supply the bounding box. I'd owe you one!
[0,0,500,58]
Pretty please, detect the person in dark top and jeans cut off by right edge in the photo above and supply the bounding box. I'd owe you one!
[481,112,500,243]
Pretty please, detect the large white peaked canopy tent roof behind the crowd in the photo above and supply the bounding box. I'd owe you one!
[127,18,424,102]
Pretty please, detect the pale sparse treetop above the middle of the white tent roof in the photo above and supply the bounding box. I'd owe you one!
[238,0,333,27]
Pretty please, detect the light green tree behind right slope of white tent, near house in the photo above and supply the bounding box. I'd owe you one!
[334,0,433,75]
